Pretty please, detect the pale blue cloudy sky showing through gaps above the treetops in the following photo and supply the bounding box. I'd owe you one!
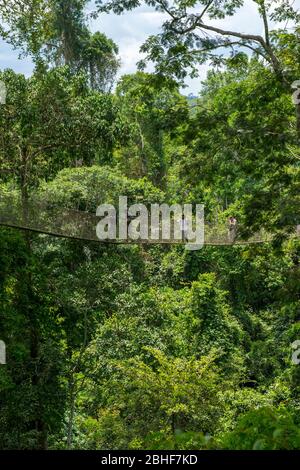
[0,0,300,94]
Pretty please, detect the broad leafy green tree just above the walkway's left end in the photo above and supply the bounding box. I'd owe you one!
[0,68,122,204]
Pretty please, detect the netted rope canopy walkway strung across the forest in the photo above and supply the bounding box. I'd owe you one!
[0,197,300,246]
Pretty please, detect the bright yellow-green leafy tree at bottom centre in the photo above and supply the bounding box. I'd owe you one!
[75,348,223,449]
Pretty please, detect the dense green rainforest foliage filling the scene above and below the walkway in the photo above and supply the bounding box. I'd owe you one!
[0,0,300,450]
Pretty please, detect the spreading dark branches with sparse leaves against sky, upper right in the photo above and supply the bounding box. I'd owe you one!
[96,0,299,78]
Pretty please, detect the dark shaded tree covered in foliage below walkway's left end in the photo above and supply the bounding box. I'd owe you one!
[0,229,66,449]
